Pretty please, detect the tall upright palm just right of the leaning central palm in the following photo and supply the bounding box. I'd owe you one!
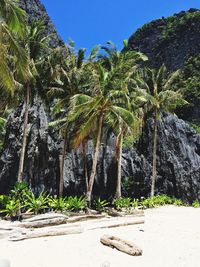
[100,41,147,198]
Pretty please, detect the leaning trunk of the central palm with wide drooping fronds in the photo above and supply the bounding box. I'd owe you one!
[86,114,103,207]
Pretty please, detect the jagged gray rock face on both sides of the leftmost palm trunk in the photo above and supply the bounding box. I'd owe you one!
[0,97,59,193]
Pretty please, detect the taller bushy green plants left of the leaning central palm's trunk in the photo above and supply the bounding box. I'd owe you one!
[0,182,86,217]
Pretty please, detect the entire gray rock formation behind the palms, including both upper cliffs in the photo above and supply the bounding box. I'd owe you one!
[0,0,200,201]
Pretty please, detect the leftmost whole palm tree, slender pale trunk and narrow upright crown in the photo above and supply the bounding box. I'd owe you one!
[17,22,50,182]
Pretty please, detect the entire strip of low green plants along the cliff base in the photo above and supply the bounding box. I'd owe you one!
[0,182,200,221]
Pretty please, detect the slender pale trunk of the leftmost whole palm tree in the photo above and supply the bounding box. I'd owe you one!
[17,85,30,182]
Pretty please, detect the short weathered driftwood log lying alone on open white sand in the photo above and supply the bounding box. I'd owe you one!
[100,235,142,256]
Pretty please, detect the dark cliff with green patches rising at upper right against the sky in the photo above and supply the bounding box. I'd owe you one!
[128,9,200,71]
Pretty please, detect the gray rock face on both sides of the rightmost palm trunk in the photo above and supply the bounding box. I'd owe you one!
[124,115,200,201]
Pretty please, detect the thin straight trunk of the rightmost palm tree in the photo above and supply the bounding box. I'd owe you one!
[151,110,158,196]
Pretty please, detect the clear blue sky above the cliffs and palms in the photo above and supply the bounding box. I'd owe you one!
[41,0,200,49]
